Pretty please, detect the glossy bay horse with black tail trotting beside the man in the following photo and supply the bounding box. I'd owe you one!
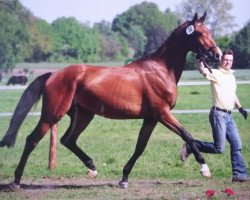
[0,13,221,188]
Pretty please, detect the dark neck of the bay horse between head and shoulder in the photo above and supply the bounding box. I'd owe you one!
[153,40,188,84]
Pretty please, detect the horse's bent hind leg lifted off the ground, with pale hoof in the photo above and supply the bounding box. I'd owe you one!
[61,106,96,178]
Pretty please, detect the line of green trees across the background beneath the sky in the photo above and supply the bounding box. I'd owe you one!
[0,0,250,72]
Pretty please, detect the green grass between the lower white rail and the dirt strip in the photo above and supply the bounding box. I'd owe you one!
[0,114,250,179]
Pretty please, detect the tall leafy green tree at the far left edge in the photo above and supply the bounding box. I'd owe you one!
[0,0,30,71]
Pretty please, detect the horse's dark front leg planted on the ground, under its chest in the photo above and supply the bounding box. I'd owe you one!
[119,119,157,188]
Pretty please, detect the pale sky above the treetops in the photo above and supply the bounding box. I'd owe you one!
[20,0,250,29]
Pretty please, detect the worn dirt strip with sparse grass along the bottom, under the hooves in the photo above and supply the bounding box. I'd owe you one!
[0,178,250,200]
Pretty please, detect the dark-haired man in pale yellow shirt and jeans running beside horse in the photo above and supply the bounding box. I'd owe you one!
[180,50,249,182]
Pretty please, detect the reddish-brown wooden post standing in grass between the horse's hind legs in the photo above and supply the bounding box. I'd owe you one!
[49,124,58,170]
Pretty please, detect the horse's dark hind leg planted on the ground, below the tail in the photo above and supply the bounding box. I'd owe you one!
[12,120,50,186]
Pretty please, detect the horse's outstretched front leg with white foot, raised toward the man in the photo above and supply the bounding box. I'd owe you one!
[160,111,211,177]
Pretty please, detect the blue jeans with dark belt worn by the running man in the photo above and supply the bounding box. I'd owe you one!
[192,109,247,178]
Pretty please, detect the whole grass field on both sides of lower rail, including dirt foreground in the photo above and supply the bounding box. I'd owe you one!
[0,65,250,199]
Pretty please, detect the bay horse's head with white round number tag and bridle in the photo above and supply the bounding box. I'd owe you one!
[185,12,222,62]
